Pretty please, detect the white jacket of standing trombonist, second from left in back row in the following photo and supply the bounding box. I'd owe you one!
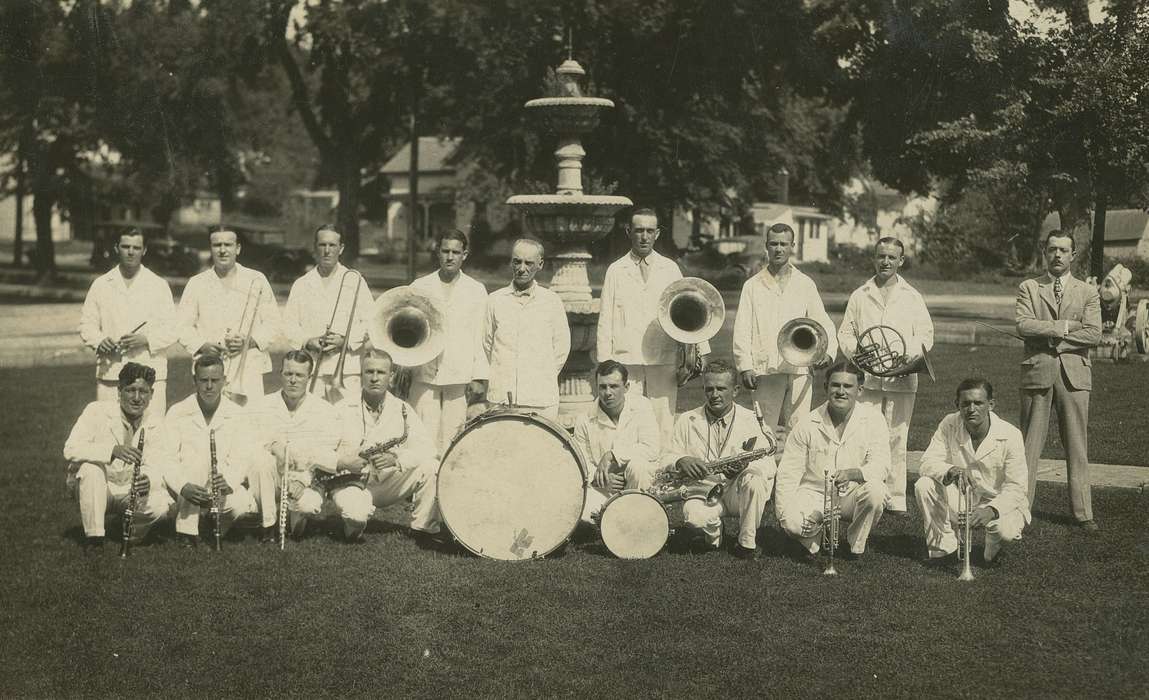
[179,263,280,374]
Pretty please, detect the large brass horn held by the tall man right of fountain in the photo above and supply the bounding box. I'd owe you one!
[658,277,726,386]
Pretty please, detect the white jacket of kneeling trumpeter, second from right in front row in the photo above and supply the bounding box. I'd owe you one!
[774,403,889,520]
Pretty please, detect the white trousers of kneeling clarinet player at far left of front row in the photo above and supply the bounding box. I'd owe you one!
[67,462,172,541]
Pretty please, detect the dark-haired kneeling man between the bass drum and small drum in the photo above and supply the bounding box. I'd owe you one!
[575,360,660,520]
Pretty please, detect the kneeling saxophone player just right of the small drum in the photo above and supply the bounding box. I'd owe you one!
[663,360,774,559]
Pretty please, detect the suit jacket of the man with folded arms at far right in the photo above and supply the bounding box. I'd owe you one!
[1013,272,1101,391]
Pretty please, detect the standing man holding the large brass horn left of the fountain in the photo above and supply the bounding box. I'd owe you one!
[408,231,487,454]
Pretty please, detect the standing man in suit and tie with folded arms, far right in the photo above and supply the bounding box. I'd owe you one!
[1015,230,1101,532]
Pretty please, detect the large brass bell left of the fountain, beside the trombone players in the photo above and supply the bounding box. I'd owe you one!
[368,286,446,367]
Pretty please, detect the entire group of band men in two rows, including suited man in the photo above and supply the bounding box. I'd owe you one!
[63,209,1101,562]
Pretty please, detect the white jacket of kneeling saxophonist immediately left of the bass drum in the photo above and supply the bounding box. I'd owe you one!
[337,393,439,474]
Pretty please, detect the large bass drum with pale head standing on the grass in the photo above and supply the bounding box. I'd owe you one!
[438,413,586,561]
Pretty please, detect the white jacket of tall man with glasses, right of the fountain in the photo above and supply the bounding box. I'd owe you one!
[595,251,710,364]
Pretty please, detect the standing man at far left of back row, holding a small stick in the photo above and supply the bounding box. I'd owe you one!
[79,229,177,416]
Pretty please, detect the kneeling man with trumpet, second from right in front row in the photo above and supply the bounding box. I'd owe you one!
[774,362,889,555]
